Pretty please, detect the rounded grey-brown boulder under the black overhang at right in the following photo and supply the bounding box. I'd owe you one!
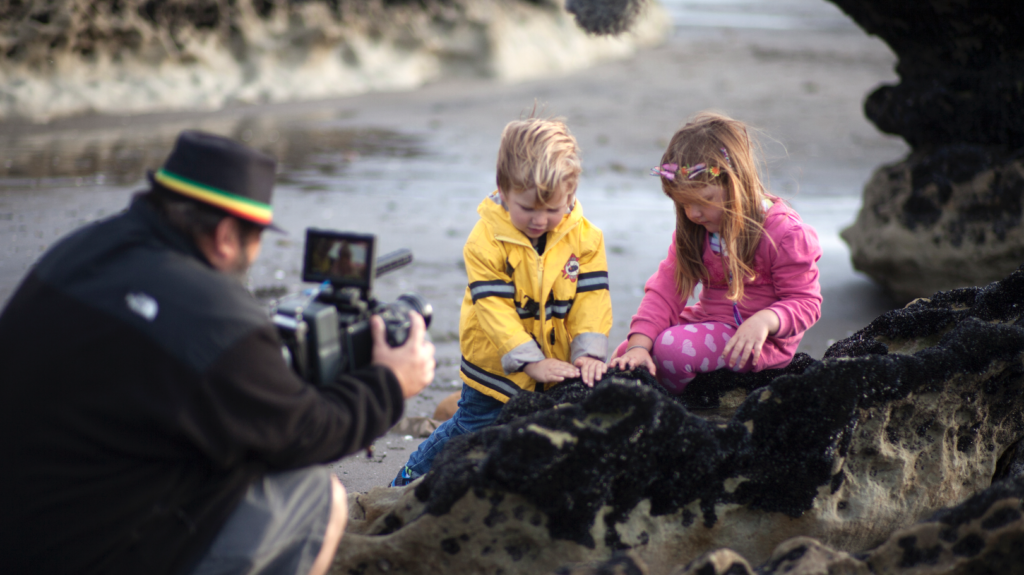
[842,144,1024,301]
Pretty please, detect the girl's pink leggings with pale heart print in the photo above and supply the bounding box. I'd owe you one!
[615,321,754,394]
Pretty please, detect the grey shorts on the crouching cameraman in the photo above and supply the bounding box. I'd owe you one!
[193,466,332,575]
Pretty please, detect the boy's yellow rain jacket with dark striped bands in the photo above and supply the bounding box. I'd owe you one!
[459,191,611,402]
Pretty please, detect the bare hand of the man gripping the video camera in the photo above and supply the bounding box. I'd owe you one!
[370,311,436,399]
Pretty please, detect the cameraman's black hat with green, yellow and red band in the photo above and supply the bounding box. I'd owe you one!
[150,130,278,229]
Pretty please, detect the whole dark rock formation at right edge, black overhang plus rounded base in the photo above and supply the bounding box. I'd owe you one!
[830,0,1024,299]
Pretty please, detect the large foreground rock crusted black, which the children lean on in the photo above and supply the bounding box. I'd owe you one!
[335,269,1024,575]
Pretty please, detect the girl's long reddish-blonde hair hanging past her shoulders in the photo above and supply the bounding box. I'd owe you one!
[662,112,765,302]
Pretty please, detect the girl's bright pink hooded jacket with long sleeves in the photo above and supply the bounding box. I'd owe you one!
[630,197,821,371]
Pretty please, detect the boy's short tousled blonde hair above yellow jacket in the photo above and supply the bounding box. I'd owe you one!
[498,118,583,206]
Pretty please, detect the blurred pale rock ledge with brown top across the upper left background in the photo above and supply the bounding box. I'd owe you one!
[0,0,671,122]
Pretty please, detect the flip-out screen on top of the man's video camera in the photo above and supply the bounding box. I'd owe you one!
[302,228,377,292]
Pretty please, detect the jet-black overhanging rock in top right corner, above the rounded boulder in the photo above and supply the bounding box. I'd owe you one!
[829,0,1024,151]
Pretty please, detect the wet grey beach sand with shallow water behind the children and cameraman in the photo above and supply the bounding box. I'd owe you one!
[0,22,907,491]
